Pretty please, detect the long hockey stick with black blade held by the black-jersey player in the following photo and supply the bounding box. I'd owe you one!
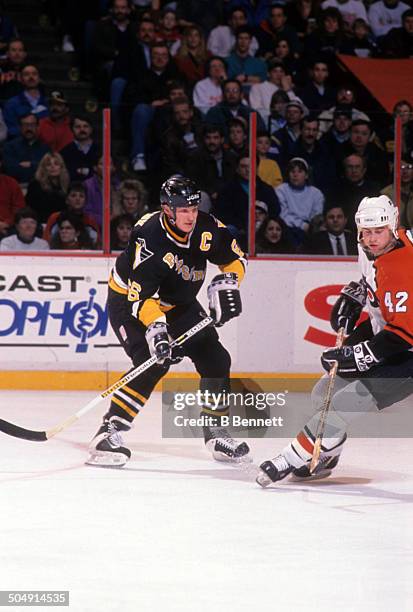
[0,317,213,442]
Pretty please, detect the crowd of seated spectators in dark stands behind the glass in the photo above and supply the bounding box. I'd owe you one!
[0,0,413,255]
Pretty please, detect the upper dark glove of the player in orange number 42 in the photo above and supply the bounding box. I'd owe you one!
[330,280,367,335]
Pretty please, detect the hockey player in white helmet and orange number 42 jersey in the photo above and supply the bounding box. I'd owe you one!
[257,195,413,487]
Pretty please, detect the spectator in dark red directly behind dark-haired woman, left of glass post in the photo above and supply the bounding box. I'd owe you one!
[43,181,100,247]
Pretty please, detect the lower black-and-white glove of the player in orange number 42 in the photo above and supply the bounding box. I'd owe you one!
[321,340,380,375]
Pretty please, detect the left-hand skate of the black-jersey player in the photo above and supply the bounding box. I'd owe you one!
[85,416,131,467]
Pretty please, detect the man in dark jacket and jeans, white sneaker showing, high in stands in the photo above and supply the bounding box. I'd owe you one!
[125,43,179,172]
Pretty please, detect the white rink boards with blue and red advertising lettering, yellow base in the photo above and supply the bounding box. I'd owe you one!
[0,255,359,389]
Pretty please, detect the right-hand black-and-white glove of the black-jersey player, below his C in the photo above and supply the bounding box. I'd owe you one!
[207,272,242,327]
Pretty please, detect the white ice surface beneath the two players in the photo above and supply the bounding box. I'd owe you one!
[0,391,413,612]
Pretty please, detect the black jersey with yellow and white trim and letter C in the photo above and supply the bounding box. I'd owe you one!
[109,212,246,325]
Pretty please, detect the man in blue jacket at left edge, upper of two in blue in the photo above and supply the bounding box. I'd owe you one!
[4,65,49,137]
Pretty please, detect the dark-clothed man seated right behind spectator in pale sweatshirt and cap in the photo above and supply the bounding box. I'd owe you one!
[291,115,337,191]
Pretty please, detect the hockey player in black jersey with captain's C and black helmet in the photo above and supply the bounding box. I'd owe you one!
[87,176,249,466]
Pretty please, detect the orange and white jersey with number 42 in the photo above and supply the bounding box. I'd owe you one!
[359,229,413,344]
